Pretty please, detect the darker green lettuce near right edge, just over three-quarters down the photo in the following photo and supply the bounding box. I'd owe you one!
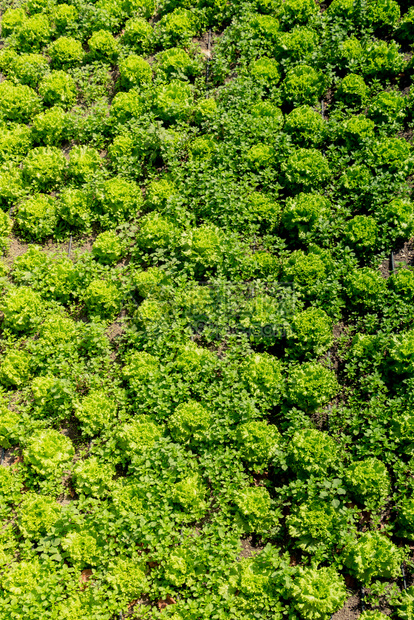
[345,457,390,508]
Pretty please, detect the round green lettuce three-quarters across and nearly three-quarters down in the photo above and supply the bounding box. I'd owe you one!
[287,428,339,477]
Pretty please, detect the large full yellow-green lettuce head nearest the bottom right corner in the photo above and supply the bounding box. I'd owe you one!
[344,532,404,584]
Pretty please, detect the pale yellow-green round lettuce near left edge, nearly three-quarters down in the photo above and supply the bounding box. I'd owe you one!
[23,428,75,476]
